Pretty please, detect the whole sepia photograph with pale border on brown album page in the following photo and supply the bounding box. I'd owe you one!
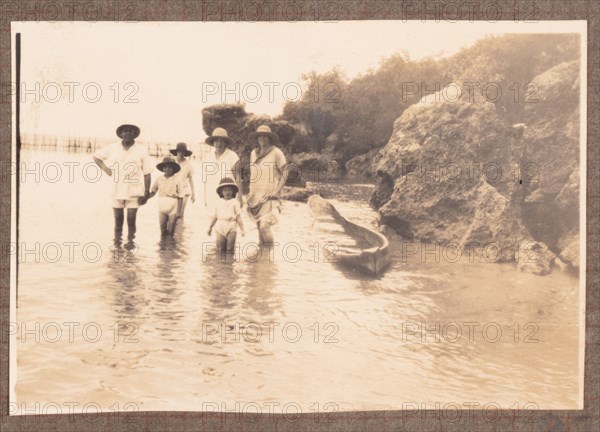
[8,15,588,421]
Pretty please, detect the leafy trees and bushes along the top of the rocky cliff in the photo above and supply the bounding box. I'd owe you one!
[280,34,579,161]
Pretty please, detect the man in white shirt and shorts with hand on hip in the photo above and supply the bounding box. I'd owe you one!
[92,124,153,249]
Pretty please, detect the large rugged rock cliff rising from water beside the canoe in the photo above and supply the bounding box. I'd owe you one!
[372,62,579,274]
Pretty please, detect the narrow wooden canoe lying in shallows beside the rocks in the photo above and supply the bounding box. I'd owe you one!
[308,195,390,276]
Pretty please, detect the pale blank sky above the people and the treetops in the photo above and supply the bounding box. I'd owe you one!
[12,21,581,143]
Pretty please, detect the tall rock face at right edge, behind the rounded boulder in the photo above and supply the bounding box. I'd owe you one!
[523,61,580,267]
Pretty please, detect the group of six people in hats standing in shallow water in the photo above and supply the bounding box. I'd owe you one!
[92,124,287,252]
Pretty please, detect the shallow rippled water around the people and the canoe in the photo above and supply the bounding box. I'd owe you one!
[15,151,580,412]
